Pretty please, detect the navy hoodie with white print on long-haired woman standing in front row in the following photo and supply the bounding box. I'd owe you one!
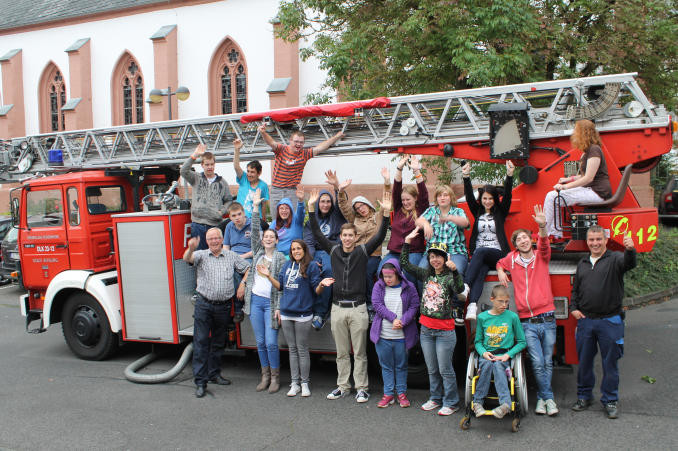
[278,260,322,316]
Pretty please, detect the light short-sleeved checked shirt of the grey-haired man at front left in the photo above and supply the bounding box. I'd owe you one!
[193,249,250,301]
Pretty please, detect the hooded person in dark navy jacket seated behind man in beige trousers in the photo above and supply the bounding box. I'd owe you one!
[304,190,346,330]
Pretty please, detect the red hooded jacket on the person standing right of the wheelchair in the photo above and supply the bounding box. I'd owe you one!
[497,236,555,318]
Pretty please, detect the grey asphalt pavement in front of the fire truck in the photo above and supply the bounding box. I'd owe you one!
[0,286,678,450]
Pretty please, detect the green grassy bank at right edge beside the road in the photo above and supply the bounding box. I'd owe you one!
[624,225,678,297]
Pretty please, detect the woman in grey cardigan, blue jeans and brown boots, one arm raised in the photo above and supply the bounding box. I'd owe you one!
[241,189,286,393]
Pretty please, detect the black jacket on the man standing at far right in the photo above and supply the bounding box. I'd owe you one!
[570,249,636,318]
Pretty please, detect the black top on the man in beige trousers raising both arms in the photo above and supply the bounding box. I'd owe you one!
[308,214,389,301]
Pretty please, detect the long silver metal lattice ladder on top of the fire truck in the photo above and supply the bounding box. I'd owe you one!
[0,74,668,177]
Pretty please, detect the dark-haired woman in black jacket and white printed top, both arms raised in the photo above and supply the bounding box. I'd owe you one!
[461,160,515,320]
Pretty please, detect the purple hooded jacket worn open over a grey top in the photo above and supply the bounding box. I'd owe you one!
[370,258,419,349]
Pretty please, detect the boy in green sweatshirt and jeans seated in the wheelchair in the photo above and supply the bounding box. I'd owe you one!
[473,285,526,418]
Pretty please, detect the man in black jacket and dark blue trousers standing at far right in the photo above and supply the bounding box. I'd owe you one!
[570,225,636,418]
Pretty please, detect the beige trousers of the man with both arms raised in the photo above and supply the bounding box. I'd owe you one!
[330,304,369,391]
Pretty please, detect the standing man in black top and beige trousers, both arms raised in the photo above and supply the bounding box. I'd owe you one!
[308,191,391,403]
